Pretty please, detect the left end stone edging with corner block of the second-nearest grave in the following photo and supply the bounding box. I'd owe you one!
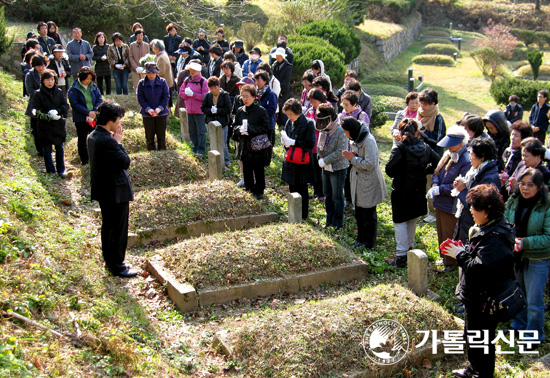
[147,259,199,312]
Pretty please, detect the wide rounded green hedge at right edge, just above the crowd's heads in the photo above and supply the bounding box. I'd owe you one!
[490,78,550,109]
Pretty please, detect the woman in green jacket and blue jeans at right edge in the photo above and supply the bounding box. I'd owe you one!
[504,168,550,342]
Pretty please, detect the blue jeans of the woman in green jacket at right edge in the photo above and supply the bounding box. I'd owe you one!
[512,259,550,341]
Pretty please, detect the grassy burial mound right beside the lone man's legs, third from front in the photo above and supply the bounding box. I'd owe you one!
[130,181,267,230]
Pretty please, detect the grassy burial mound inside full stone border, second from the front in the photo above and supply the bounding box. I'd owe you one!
[159,224,353,291]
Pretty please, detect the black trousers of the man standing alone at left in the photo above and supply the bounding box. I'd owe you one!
[99,201,130,274]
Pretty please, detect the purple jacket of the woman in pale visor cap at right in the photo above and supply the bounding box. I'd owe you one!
[432,146,470,214]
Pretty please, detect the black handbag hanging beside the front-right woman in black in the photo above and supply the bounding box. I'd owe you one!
[487,280,527,322]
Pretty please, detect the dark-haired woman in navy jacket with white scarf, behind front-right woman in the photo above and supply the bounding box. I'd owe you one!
[453,138,500,243]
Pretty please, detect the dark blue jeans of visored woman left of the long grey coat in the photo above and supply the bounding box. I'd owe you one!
[323,169,347,227]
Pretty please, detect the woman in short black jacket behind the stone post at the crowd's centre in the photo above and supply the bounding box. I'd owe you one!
[201,76,233,165]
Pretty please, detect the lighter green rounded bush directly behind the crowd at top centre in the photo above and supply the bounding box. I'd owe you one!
[288,42,346,88]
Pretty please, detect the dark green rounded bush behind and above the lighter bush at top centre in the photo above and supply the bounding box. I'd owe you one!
[296,20,361,64]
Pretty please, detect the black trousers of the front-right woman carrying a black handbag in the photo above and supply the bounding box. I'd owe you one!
[464,304,497,378]
